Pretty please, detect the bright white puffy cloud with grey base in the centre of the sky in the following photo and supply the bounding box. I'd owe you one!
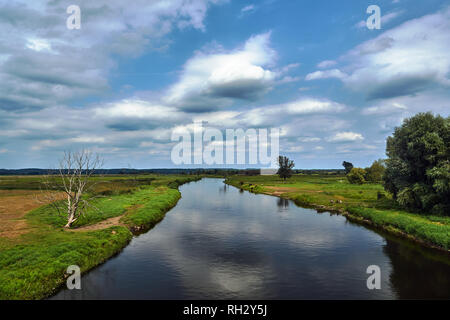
[165,33,276,112]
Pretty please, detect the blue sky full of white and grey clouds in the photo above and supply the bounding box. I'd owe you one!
[0,0,450,168]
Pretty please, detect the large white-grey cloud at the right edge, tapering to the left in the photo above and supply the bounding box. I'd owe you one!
[307,8,450,99]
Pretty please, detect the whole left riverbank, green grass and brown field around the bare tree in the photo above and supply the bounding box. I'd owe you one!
[0,175,198,299]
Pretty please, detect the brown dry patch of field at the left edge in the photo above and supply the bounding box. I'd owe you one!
[0,190,62,239]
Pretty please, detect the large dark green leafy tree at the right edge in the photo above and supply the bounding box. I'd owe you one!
[383,113,450,214]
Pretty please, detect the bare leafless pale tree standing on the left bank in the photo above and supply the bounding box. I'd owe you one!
[42,150,103,228]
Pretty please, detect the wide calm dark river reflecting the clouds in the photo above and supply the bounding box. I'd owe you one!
[52,179,450,299]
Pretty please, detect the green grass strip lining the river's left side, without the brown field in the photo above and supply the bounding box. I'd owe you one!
[0,176,202,300]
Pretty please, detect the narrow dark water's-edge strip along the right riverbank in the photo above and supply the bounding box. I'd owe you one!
[223,179,450,254]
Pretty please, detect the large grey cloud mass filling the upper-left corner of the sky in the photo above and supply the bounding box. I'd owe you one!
[0,0,221,112]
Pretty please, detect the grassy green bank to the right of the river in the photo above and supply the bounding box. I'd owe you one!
[226,175,450,251]
